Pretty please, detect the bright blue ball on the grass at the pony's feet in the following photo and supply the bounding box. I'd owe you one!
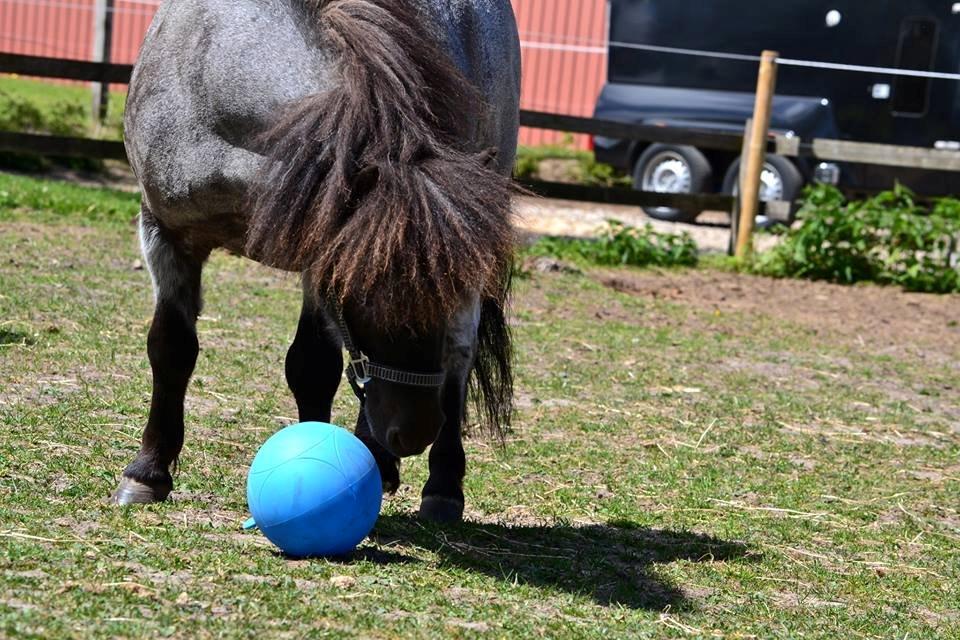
[247,422,383,557]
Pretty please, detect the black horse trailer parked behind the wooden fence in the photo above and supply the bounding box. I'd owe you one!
[594,0,960,221]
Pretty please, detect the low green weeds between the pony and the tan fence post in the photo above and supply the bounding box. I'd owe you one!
[529,220,697,267]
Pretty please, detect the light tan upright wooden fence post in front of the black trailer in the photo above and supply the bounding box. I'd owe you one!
[736,51,780,259]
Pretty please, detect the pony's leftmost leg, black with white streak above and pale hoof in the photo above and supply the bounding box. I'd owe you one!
[112,208,206,504]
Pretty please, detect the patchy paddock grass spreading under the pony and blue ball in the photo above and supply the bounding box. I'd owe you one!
[0,176,960,638]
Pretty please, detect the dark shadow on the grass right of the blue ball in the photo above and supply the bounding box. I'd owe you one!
[374,515,757,611]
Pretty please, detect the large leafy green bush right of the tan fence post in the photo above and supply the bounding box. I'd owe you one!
[750,185,960,293]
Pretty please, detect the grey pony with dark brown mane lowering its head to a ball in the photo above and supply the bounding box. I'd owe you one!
[112,0,520,521]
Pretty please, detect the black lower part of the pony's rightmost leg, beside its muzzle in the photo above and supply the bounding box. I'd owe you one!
[420,379,467,522]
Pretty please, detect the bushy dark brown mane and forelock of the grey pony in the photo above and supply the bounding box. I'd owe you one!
[246,0,513,330]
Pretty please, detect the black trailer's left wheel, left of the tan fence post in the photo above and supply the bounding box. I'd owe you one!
[633,144,713,222]
